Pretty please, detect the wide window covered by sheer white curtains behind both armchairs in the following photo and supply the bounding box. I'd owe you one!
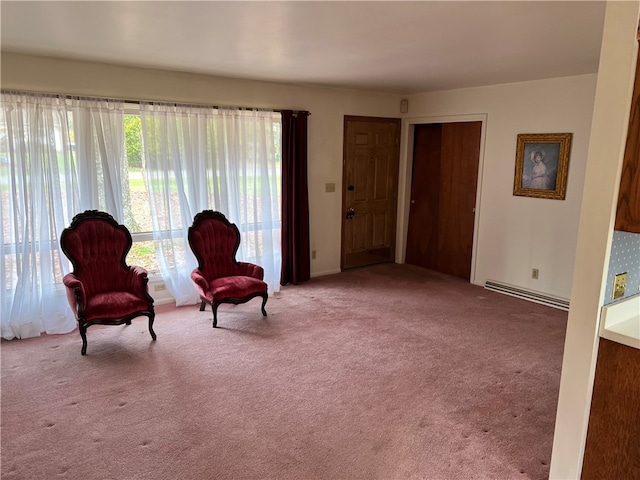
[0,92,281,339]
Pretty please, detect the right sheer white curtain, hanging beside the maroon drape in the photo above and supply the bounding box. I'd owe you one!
[140,103,281,305]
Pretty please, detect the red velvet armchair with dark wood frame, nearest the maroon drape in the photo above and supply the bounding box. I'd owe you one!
[188,210,269,328]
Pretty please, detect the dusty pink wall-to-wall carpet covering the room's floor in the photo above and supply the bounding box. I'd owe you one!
[1,264,567,480]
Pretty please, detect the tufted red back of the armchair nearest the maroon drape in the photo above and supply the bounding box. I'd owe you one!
[189,210,240,281]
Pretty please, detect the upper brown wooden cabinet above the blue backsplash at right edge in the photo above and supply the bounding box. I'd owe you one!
[615,42,640,233]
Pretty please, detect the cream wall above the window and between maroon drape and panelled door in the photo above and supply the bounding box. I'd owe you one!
[1,53,400,276]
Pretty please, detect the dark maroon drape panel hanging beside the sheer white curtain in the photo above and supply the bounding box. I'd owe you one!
[280,110,311,285]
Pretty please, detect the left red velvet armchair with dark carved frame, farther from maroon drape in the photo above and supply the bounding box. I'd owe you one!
[60,210,156,355]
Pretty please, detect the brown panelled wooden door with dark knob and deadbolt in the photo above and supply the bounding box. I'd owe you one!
[340,116,400,270]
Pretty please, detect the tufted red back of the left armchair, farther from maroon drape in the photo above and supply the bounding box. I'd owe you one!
[60,210,132,296]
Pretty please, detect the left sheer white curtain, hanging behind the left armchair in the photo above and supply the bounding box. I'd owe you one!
[0,92,123,340]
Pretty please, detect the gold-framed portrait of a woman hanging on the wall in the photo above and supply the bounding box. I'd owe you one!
[513,133,573,200]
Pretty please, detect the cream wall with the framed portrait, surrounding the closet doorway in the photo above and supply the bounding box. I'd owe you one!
[398,74,597,299]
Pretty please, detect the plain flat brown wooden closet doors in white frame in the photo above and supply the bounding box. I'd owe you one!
[405,122,482,280]
